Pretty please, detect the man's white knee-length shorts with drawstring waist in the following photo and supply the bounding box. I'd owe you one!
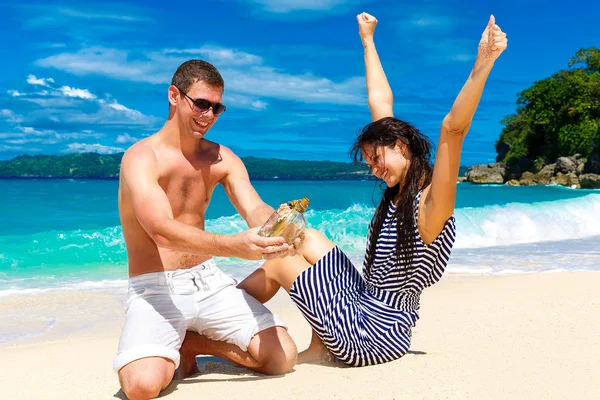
[113,259,287,372]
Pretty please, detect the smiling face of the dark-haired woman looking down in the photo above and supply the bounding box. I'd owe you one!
[361,140,410,187]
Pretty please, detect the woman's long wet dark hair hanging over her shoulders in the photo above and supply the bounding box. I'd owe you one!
[350,117,433,277]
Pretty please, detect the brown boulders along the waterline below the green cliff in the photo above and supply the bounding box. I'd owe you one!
[466,154,600,189]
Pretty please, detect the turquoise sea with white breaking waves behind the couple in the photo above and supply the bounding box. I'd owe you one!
[0,180,600,296]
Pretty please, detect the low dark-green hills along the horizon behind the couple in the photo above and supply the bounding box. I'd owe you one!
[0,153,468,180]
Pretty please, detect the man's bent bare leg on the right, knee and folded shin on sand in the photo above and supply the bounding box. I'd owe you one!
[180,327,298,377]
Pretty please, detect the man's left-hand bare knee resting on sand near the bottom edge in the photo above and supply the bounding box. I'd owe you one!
[119,359,175,400]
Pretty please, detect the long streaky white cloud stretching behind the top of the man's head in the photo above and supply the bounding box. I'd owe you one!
[36,46,365,105]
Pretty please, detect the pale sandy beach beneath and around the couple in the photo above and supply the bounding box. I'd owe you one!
[0,272,600,400]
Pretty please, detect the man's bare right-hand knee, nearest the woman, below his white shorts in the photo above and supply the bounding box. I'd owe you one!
[258,327,298,375]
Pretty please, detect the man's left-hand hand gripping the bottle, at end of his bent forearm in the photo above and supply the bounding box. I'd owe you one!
[234,227,293,260]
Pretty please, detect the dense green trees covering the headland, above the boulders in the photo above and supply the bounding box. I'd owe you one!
[496,47,600,171]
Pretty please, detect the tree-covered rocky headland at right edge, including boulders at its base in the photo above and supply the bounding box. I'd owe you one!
[466,47,600,189]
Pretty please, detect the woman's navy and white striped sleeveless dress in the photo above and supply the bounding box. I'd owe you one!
[290,192,455,367]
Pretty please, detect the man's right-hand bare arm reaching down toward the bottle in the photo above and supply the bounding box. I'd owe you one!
[221,152,274,228]
